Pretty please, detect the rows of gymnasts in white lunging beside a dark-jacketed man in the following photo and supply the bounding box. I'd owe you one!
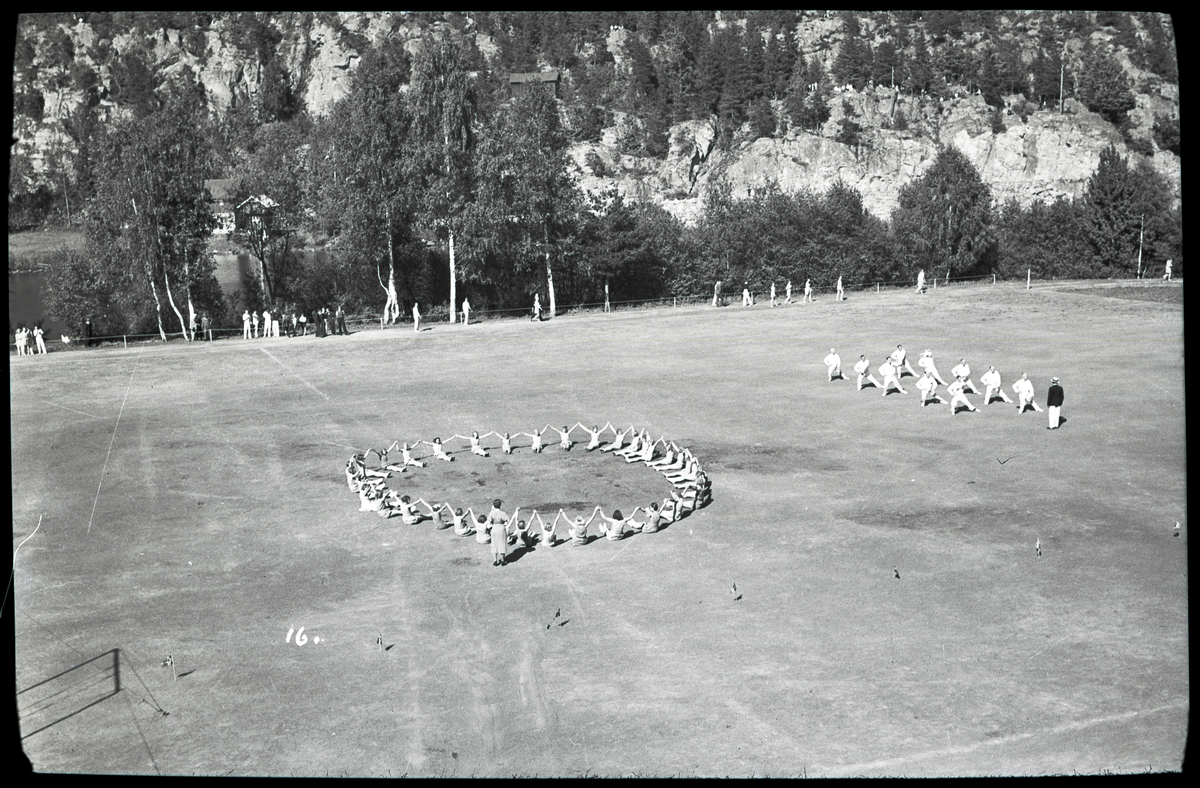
[824,344,1042,416]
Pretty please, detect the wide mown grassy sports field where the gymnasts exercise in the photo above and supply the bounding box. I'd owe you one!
[10,278,1189,776]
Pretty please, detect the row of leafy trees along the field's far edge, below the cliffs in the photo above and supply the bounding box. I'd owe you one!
[23,14,1182,336]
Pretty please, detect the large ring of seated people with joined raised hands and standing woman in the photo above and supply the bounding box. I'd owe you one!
[346,422,713,566]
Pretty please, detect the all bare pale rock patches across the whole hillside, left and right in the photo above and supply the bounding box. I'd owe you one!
[13,12,1181,222]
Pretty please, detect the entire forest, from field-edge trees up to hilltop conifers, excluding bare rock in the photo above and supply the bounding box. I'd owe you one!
[10,11,1182,337]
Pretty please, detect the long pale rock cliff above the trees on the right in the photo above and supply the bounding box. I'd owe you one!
[571,96,1182,223]
